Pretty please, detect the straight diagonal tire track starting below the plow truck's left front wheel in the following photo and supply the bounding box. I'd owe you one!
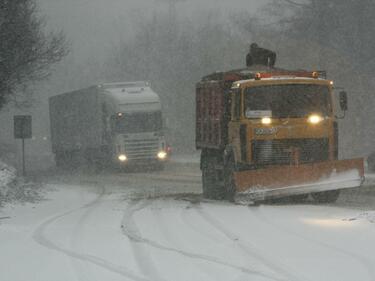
[192,203,310,281]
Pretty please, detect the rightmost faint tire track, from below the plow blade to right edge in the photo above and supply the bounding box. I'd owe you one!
[251,206,375,281]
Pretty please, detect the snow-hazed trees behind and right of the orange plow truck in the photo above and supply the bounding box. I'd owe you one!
[233,0,375,157]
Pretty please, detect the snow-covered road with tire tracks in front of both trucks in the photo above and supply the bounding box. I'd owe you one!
[0,164,375,281]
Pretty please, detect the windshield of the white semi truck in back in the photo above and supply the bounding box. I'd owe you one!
[115,111,162,134]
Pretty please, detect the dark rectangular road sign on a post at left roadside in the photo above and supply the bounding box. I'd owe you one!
[13,115,32,176]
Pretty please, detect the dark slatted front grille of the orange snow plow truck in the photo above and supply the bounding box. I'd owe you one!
[251,138,329,165]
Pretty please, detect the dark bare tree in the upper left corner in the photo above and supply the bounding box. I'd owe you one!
[0,0,68,109]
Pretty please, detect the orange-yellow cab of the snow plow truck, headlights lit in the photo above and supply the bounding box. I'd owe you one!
[228,74,338,168]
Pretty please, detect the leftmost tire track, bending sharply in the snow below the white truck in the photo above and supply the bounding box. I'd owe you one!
[33,184,153,281]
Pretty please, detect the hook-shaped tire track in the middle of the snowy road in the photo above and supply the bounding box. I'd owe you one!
[121,198,279,280]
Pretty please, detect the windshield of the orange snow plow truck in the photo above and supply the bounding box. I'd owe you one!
[244,84,331,118]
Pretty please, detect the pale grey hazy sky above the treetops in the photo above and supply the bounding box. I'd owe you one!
[38,0,267,59]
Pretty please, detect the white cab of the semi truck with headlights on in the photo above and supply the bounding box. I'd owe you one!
[101,81,170,167]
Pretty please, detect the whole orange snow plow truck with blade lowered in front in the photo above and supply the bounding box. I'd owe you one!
[196,65,364,202]
